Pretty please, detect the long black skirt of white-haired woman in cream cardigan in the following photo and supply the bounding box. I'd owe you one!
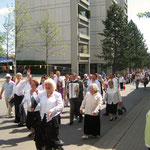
[84,114,101,136]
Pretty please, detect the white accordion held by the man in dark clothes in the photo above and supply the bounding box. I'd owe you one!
[69,83,79,98]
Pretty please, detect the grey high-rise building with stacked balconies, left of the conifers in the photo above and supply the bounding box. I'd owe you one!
[17,0,127,74]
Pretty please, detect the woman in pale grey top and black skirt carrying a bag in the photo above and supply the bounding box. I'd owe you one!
[104,81,122,121]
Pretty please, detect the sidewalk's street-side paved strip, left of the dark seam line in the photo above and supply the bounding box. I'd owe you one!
[88,94,150,150]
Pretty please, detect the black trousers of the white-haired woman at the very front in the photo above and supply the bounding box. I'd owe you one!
[35,115,60,150]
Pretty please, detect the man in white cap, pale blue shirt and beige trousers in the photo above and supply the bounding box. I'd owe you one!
[0,74,14,118]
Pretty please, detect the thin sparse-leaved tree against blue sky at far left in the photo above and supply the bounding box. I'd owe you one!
[3,8,14,71]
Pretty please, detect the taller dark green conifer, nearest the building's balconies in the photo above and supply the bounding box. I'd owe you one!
[100,2,127,72]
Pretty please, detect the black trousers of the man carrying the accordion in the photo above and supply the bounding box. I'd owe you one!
[70,98,82,122]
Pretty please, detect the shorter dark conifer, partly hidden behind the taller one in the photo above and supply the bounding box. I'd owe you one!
[127,20,149,68]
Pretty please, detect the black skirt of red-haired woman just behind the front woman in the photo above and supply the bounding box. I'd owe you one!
[26,111,41,130]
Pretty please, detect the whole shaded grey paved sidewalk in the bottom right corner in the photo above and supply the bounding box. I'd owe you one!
[89,89,150,150]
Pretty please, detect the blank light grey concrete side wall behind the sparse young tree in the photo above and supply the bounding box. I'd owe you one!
[17,0,71,64]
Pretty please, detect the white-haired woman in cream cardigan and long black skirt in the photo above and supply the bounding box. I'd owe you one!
[80,83,102,139]
